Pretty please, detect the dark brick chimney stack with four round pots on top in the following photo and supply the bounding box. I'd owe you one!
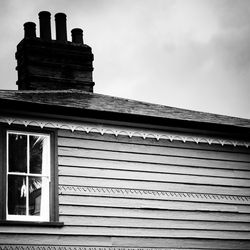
[16,11,94,92]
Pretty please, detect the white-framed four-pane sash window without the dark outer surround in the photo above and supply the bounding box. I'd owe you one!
[6,131,50,221]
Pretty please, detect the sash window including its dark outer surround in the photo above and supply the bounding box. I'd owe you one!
[0,129,60,225]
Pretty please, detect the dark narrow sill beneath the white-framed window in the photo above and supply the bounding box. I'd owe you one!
[0,220,64,227]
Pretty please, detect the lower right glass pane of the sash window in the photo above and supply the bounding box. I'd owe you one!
[29,177,42,215]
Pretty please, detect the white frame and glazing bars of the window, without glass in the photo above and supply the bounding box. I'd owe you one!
[6,130,51,222]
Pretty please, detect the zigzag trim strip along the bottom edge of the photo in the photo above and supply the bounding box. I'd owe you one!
[0,245,180,250]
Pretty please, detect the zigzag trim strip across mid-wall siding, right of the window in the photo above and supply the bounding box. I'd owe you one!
[59,185,250,204]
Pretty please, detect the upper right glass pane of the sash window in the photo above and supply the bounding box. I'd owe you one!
[29,136,45,174]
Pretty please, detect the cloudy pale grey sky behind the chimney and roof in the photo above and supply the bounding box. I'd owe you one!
[0,0,250,119]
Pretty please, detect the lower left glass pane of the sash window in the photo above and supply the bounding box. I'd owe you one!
[8,175,27,215]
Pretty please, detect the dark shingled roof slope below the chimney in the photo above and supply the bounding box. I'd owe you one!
[0,90,250,128]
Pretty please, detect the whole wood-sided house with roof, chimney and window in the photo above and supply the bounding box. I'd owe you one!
[0,11,250,250]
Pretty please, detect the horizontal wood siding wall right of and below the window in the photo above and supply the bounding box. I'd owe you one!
[0,130,250,250]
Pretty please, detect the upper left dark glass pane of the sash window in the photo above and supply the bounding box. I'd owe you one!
[9,134,27,172]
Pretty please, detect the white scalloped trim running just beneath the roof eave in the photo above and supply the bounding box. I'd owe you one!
[0,116,250,148]
